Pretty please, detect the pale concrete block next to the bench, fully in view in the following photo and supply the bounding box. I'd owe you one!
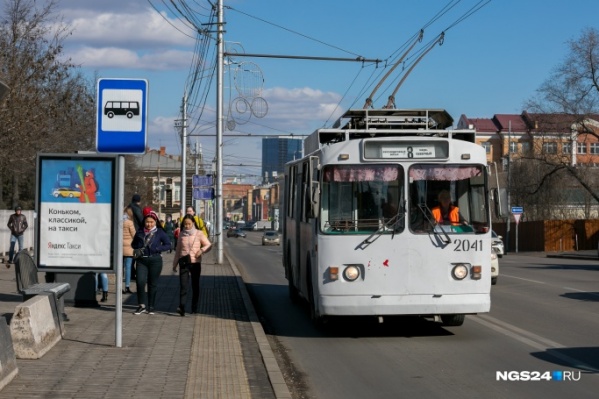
[10,293,64,359]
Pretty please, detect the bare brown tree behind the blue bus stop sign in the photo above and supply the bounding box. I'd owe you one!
[0,0,95,206]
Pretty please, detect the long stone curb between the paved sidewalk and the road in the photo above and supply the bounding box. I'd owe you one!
[225,254,291,399]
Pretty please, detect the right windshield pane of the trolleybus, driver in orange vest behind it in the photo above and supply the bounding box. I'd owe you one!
[408,165,489,233]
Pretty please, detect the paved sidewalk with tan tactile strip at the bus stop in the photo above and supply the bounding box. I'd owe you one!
[0,251,291,399]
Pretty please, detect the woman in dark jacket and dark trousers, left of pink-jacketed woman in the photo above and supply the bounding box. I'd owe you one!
[131,211,171,314]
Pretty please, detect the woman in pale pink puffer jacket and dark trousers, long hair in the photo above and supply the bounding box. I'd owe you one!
[173,215,212,316]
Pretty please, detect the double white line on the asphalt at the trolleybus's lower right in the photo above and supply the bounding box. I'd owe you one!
[469,314,599,373]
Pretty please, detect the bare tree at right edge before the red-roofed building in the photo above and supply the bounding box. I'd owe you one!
[519,28,599,212]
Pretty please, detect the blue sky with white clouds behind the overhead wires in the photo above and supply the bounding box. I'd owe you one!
[47,0,599,181]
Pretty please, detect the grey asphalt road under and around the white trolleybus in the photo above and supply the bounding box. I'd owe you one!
[225,232,599,399]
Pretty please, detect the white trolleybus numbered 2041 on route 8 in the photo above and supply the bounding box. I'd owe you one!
[282,109,491,326]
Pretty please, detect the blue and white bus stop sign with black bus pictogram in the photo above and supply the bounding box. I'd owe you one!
[96,79,148,154]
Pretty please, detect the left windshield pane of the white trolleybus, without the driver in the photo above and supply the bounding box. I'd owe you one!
[320,165,404,234]
